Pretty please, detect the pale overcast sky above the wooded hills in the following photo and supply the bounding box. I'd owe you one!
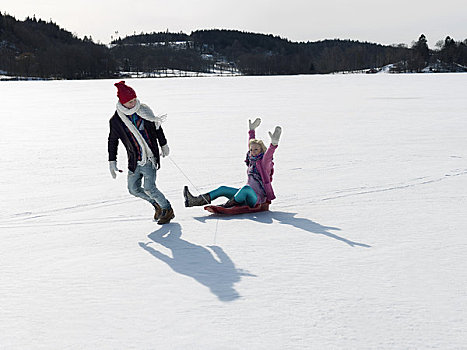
[0,0,467,48]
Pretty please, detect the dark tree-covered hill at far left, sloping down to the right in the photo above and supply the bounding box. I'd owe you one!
[0,15,116,79]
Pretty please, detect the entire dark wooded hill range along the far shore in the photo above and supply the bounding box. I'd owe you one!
[0,13,467,79]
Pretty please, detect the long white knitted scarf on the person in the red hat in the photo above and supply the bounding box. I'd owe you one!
[117,99,167,168]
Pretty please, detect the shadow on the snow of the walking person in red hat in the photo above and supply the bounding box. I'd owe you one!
[139,223,256,301]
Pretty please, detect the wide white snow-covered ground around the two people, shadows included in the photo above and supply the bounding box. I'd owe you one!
[0,74,467,350]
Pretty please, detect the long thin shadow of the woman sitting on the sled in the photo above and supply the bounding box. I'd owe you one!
[195,211,371,248]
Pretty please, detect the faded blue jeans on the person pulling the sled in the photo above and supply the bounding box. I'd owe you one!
[128,162,170,209]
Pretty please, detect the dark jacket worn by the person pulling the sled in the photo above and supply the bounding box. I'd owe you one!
[108,112,167,172]
